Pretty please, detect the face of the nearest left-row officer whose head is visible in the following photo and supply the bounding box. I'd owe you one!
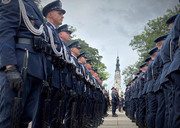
[50,10,64,27]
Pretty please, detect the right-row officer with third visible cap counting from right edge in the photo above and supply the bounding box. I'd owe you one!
[146,47,158,128]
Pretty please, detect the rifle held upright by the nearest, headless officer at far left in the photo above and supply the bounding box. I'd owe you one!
[11,49,29,128]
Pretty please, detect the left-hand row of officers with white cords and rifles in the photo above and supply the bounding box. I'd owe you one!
[0,0,109,128]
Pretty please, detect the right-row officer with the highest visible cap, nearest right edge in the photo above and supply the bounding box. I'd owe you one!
[160,15,176,128]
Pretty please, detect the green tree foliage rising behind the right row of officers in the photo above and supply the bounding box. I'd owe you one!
[123,5,180,84]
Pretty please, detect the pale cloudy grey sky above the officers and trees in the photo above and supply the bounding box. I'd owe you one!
[41,0,179,90]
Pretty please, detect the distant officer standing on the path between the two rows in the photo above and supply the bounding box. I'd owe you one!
[111,87,119,117]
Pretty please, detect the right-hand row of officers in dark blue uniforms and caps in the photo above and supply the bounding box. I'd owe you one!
[125,14,180,128]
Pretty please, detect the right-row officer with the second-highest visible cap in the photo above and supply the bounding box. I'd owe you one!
[153,35,167,128]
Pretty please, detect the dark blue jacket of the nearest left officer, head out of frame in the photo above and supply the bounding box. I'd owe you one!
[0,0,46,79]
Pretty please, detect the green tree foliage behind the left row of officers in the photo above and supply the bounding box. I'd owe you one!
[68,39,110,80]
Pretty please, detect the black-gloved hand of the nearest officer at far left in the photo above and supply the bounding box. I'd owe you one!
[5,66,23,91]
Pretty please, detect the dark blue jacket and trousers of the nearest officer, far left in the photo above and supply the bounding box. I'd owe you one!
[0,0,46,128]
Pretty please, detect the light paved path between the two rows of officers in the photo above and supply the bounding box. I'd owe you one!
[98,111,138,128]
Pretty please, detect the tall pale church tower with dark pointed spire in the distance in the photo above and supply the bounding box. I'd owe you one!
[114,56,122,96]
